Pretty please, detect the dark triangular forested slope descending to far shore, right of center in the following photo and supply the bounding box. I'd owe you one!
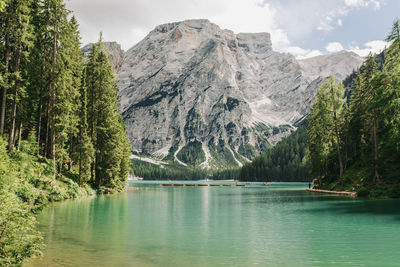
[239,121,311,182]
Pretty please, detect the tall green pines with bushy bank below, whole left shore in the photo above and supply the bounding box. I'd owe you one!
[0,0,130,266]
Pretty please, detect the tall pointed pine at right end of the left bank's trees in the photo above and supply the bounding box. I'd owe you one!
[86,37,130,189]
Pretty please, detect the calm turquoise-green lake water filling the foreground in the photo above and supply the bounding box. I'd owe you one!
[27,182,400,266]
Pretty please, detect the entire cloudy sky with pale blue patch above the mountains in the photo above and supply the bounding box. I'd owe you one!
[67,0,400,58]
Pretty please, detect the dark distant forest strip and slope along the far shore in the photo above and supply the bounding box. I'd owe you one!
[132,121,312,182]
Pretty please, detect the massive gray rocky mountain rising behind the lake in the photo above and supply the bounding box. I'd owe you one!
[112,20,362,167]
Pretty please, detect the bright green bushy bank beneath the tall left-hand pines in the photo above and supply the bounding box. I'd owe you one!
[0,137,95,266]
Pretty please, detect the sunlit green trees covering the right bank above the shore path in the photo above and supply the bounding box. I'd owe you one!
[308,20,400,197]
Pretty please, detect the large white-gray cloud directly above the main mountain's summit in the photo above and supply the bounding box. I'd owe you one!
[67,0,289,49]
